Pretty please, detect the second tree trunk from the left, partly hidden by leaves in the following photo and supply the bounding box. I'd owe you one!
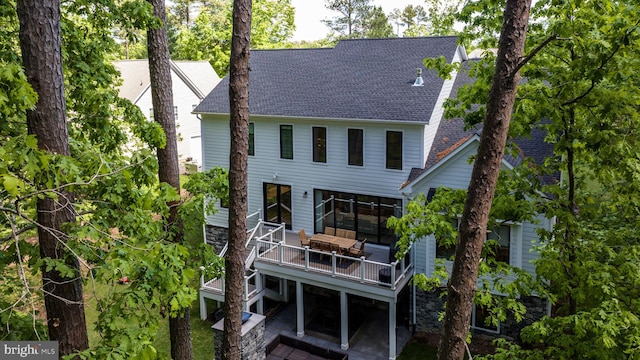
[147,0,193,360]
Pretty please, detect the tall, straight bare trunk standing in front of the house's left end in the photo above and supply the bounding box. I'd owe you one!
[222,0,251,360]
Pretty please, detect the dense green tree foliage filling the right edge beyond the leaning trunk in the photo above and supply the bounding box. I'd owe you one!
[420,0,640,359]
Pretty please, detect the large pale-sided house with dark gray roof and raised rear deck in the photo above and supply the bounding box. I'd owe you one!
[194,37,550,359]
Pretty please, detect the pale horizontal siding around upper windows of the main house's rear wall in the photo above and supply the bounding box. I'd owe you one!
[202,115,424,230]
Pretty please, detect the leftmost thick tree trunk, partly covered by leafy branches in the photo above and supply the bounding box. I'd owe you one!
[17,0,89,356]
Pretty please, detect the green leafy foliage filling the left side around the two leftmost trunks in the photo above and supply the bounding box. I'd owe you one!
[0,0,228,359]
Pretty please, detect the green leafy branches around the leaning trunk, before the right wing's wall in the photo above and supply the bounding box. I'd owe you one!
[387,170,546,325]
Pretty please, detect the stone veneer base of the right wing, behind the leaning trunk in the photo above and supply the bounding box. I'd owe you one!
[415,289,547,340]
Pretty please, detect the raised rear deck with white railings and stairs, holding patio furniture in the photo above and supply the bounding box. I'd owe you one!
[200,221,413,316]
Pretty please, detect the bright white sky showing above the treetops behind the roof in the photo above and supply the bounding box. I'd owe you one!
[291,0,425,41]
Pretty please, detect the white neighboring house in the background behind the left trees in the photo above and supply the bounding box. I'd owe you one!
[114,59,220,168]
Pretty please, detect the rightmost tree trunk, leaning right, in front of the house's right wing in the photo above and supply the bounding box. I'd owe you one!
[438,0,531,360]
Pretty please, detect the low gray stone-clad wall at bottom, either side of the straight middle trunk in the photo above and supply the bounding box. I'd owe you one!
[212,314,267,360]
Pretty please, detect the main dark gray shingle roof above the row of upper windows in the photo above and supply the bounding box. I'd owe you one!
[194,36,457,122]
